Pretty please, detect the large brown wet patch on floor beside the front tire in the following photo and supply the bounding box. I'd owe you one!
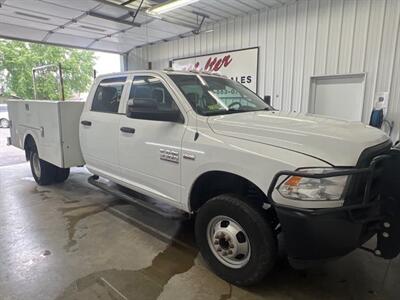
[57,242,199,300]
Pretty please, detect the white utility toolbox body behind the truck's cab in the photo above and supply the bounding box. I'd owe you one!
[7,100,85,168]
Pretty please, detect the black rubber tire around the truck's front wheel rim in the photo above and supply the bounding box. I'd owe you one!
[195,194,278,286]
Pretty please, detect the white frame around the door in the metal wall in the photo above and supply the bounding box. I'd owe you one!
[307,72,367,120]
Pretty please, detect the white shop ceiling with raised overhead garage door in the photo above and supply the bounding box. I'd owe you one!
[0,0,295,54]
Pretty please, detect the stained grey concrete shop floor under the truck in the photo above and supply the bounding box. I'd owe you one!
[0,129,400,300]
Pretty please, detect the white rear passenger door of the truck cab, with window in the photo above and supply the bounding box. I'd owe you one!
[80,76,127,176]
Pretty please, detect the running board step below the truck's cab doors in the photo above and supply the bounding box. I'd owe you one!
[88,175,190,219]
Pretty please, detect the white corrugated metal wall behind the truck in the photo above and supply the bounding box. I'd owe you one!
[128,0,400,137]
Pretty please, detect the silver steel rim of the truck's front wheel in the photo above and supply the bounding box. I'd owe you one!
[207,216,251,269]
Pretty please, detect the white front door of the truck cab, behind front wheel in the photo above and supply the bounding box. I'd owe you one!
[119,75,186,205]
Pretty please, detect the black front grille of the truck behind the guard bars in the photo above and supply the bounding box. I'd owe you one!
[345,140,392,205]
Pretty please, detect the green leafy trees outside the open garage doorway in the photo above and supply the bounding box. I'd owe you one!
[0,40,95,100]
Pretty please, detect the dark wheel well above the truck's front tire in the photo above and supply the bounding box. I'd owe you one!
[190,171,268,212]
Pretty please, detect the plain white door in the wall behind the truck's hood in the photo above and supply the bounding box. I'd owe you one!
[309,74,365,121]
